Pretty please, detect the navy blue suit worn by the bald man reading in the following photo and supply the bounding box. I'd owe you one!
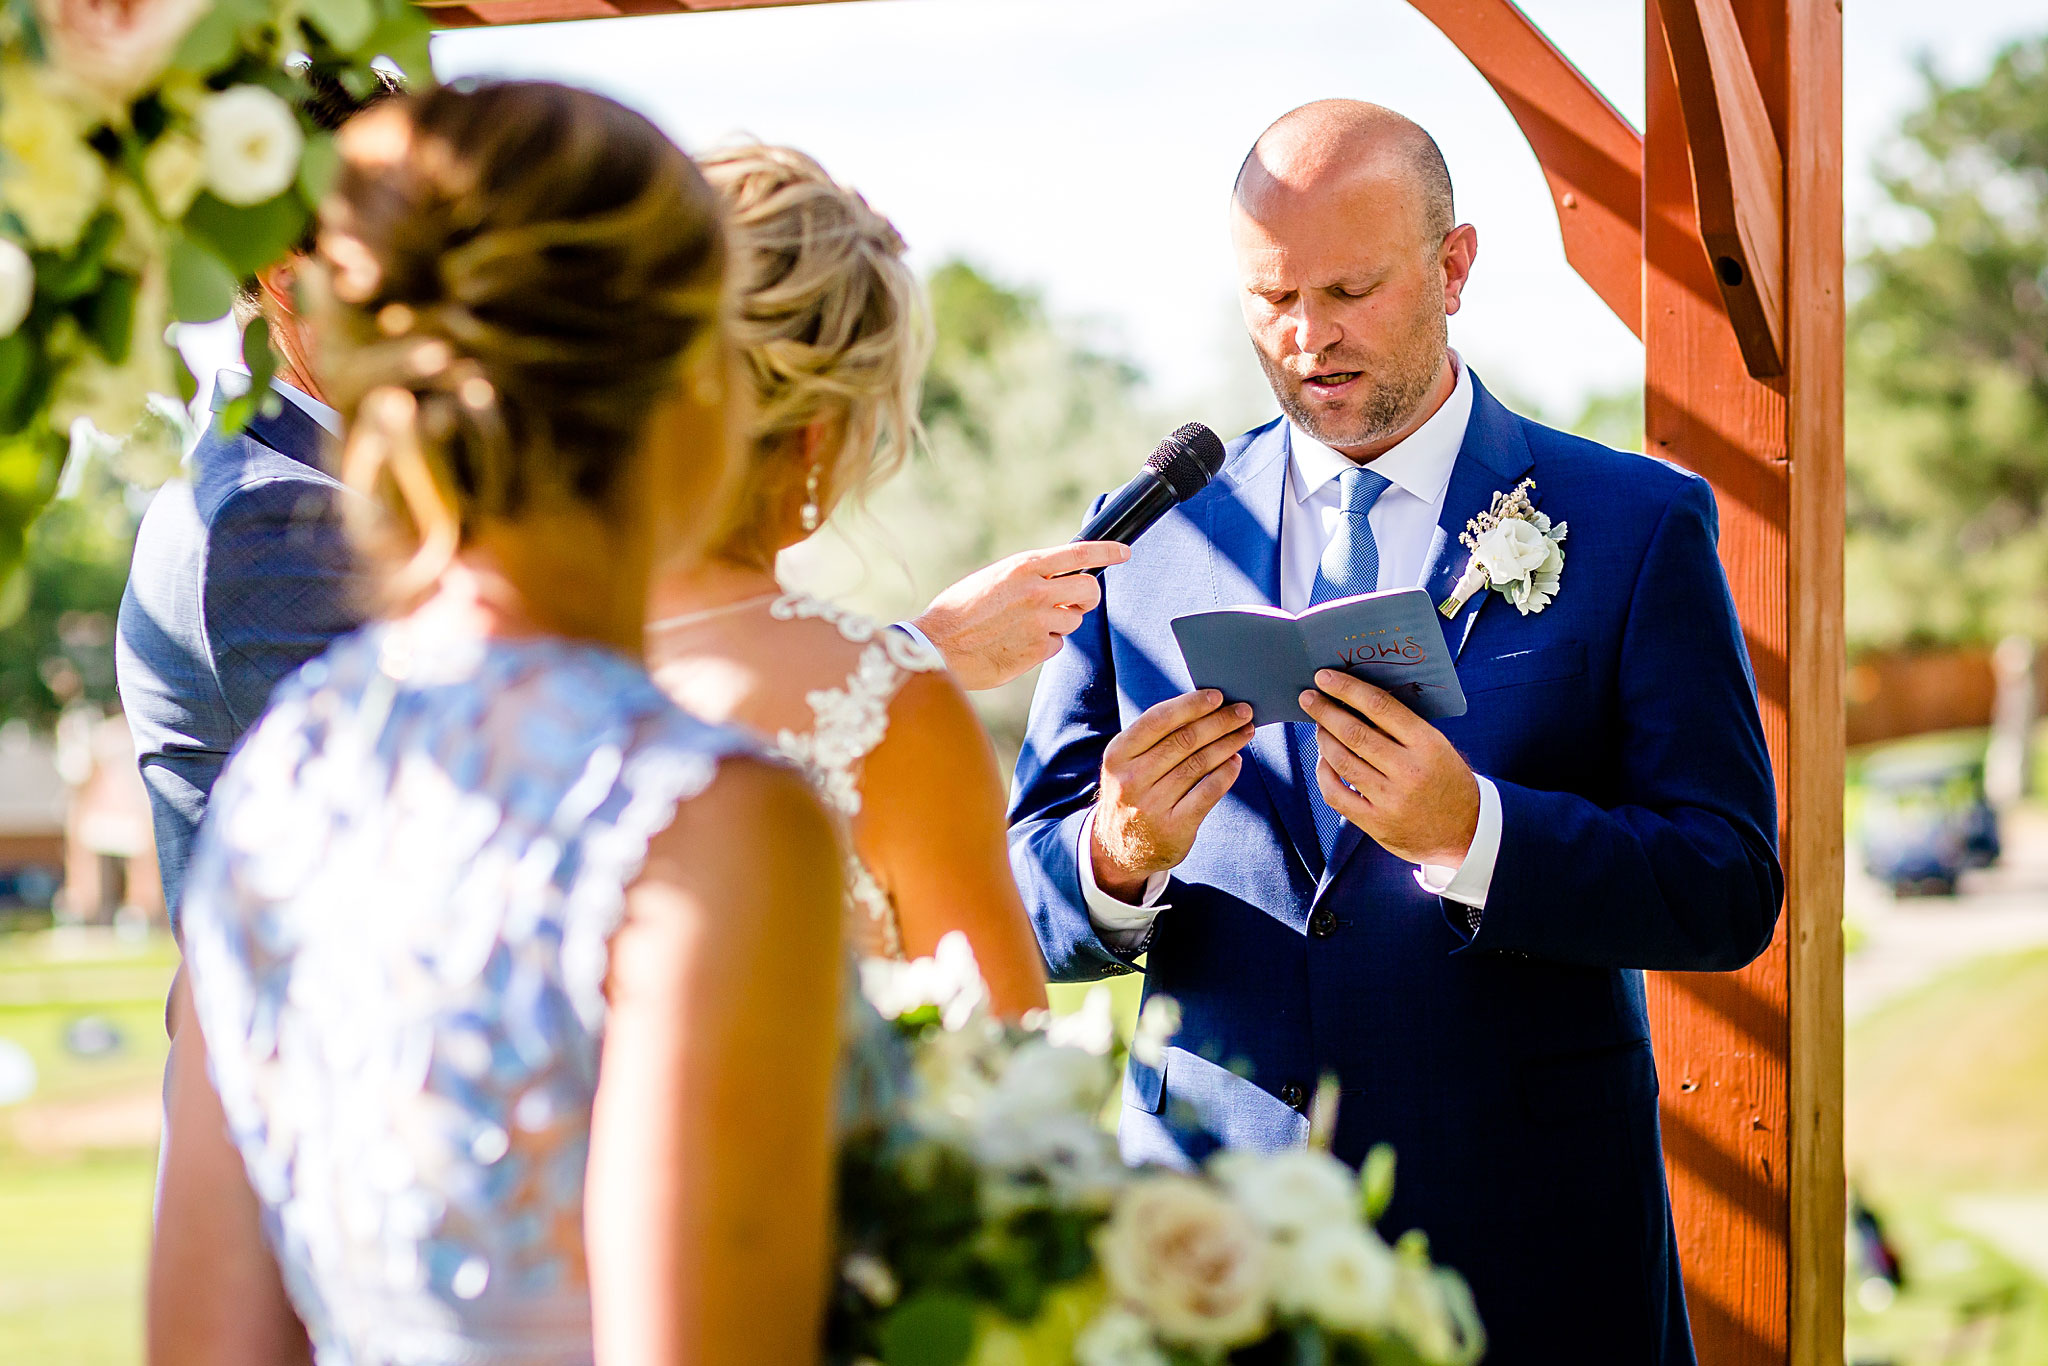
[1012,377,1782,1366]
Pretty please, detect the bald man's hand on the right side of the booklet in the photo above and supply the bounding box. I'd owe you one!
[1300,670,1479,868]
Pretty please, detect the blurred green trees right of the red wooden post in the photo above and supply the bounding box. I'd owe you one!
[1847,37,2048,647]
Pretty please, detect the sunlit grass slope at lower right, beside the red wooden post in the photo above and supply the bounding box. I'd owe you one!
[1845,952,2048,1366]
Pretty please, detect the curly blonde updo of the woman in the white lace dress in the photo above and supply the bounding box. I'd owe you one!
[700,145,932,559]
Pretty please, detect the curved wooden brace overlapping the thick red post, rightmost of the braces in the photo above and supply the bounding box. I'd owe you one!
[1655,0,1786,379]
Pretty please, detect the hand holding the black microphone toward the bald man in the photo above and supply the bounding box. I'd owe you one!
[911,541,1130,690]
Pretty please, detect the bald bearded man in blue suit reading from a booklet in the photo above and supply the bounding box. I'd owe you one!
[1012,100,1784,1366]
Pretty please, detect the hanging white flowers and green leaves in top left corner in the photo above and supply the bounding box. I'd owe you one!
[0,0,430,582]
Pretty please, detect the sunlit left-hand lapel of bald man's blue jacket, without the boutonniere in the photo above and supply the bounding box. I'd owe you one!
[1208,420,1323,877]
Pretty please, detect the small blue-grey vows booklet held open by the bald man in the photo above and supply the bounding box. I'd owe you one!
[1174,588,1464,725]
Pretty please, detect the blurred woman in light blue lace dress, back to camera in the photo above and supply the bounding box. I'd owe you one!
[150,82,844,1366]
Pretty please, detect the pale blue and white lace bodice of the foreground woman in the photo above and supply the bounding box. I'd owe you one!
[184,627,815,1366]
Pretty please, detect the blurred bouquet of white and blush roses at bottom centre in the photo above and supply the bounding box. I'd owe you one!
[827,936,1483,1366]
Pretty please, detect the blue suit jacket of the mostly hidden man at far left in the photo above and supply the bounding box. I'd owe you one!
[115,385,362,928]
